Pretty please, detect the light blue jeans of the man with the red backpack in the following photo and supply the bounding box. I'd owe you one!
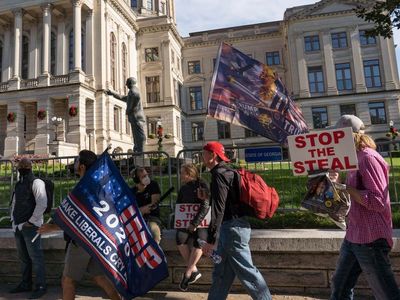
[208,218,272,300]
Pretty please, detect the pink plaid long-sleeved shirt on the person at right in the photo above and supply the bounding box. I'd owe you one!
[345,148,393,247]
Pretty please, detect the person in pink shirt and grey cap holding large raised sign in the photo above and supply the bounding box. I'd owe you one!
[329,115,400,300]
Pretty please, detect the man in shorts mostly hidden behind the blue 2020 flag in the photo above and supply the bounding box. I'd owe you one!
[38,150,121,300]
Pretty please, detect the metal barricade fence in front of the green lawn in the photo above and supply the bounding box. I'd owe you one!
[0,142,400,226]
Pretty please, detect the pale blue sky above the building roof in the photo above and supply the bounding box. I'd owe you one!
[175,0,400,69]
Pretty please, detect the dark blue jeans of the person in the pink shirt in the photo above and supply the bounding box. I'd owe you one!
[330,239,400,300]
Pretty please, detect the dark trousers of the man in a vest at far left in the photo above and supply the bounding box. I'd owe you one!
[15,226,46,287]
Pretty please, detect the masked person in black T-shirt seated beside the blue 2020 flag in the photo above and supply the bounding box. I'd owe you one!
[131,167,161,244]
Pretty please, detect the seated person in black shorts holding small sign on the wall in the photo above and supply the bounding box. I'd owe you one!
[176,164,210,291]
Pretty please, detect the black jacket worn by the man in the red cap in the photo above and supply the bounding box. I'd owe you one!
[207,162,244,244]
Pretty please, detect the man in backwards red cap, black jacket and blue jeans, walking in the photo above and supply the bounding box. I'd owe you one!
[198,142,272,300]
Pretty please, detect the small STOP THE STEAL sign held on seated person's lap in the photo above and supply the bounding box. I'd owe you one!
[174,203,211,229]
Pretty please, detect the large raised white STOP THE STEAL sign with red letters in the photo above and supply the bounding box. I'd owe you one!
[288,127,358,176]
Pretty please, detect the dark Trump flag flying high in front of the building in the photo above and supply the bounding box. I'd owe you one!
[208,43,308,143]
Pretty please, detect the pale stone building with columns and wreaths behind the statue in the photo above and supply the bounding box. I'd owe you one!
[0,0,400,157]
